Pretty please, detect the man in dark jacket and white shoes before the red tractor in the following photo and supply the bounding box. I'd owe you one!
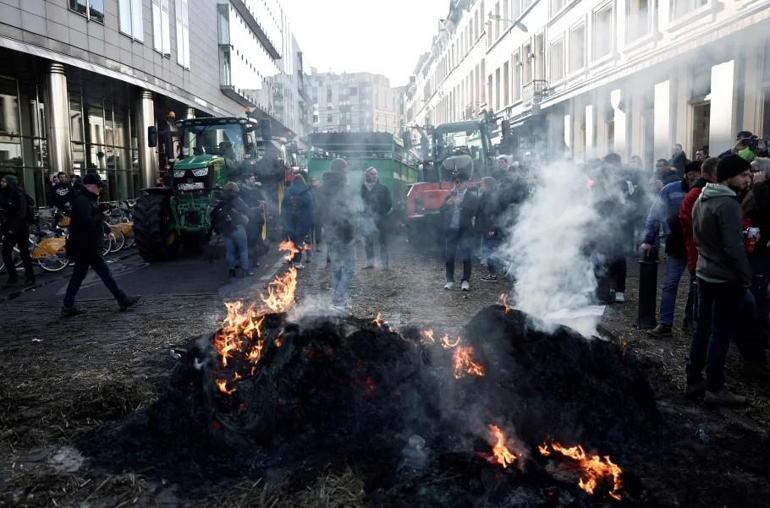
[441,171,479,291]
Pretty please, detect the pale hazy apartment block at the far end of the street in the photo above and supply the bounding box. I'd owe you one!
[309,72,402,134]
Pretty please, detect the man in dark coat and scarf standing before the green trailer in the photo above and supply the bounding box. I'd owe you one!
[361,167,393,269]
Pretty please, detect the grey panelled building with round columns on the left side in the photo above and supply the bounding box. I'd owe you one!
[0,0,300,204]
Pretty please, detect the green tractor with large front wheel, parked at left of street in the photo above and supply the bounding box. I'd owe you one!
[133,118,258,261]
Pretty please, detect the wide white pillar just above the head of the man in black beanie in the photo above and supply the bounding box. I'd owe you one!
[709,60,735,155]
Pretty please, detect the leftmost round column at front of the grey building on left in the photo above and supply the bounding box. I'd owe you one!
[45,62,72,173]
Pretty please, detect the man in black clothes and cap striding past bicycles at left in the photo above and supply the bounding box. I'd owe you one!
[61,173,139,317]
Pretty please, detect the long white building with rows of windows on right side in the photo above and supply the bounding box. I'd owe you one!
[406,0,770,167]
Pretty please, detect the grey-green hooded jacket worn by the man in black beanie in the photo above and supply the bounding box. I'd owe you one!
[692,183,752,287]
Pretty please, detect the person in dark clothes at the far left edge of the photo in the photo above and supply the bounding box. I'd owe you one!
[0,175,35,286]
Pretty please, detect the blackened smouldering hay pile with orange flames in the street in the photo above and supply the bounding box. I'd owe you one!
[123,271,657,504]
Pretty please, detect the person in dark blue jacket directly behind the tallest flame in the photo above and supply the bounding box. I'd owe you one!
[281,174,315,269]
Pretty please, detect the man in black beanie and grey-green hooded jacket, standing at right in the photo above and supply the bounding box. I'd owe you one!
[687,155,756,405]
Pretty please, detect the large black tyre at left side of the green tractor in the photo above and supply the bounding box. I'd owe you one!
[133,192,179,261]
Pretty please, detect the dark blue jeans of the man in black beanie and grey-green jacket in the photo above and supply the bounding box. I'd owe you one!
[687,279,756,391]
